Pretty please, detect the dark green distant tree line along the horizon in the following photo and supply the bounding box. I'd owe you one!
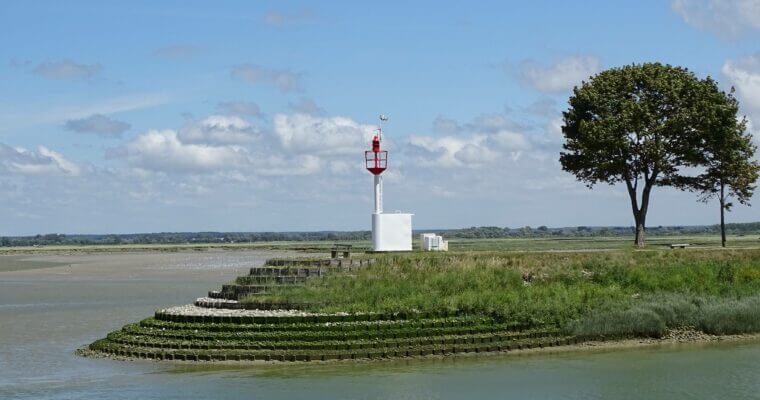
[0,222,760,247]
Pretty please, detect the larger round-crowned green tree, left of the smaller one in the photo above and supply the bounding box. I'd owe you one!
[560,63,740,246]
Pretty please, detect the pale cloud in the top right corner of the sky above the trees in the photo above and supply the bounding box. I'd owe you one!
[670,0,760,38]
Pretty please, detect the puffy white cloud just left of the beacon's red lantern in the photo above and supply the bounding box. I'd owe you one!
[273,114,377,154]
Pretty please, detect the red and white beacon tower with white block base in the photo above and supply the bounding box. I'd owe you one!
[364,115,413,251]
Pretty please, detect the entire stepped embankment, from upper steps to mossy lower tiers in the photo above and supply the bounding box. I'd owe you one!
[89,259,579,362]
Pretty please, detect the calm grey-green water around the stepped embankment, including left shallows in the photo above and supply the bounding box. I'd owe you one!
[0,252,760,399]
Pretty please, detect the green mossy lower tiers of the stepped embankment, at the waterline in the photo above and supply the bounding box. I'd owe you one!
[89,311,578,361]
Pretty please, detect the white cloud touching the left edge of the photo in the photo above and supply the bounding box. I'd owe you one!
[0,143,81,176]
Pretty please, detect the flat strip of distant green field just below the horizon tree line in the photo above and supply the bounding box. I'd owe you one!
[0,235,760,254]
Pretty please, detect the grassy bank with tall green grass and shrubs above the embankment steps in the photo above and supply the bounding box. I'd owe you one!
[247,250,760,337]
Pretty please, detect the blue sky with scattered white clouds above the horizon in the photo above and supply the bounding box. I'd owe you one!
[0,0,760,235]
